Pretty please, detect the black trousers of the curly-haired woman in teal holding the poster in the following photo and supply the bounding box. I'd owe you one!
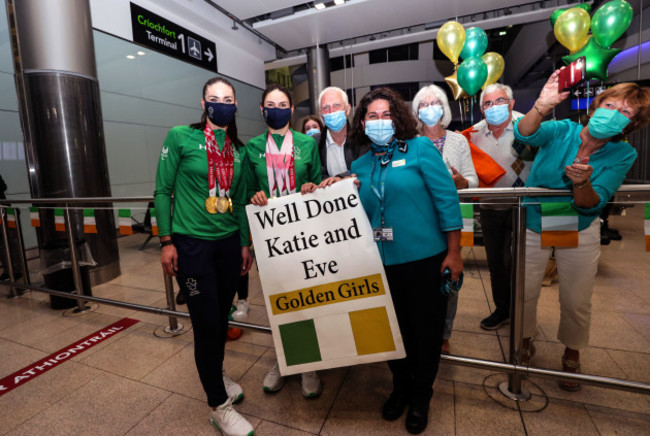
[384,252,447,402]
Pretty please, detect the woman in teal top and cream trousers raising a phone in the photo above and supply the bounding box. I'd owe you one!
[515,70,650,391]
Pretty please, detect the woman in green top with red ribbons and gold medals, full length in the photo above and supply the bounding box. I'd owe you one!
[154,77,253,435]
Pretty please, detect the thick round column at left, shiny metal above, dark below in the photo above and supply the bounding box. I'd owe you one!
[6,0,120,284]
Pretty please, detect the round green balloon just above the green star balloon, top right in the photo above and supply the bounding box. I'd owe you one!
[591,0,634,48]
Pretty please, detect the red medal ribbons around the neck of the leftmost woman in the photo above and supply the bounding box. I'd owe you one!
[203,123,235,197]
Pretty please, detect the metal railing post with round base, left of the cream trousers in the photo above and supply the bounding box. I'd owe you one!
[499,197,530,401]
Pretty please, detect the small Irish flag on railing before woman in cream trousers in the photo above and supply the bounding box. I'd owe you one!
[541,202,578,247]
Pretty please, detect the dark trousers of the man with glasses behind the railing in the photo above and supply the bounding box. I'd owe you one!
[480,209,512,315]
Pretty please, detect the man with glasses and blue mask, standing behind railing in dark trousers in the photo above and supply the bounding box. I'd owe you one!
[467,83,534,330]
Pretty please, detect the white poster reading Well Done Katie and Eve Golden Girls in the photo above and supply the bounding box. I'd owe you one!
[246,180,405,375]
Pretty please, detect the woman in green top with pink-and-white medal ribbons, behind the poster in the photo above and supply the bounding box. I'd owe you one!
[244,84,321,397]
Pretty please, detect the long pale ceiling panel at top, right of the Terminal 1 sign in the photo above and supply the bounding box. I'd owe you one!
[251,0,522,50]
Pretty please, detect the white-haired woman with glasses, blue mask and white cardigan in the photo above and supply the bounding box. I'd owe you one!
[412,85,478,354]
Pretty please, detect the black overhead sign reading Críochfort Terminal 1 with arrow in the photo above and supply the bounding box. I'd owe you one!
[131,3,217,72]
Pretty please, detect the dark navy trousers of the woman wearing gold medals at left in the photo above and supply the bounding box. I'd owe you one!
[172,233,241,407]
